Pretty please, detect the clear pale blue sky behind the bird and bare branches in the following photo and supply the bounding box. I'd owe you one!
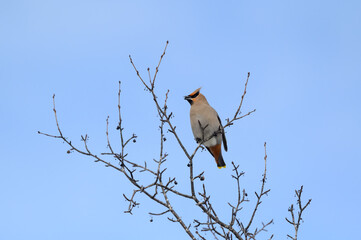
[0,0,361,240]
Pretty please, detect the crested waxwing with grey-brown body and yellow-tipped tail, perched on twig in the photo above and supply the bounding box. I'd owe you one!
[184,88,228,169]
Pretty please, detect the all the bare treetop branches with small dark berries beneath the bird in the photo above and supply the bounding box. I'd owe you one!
[38,41,311,240]
